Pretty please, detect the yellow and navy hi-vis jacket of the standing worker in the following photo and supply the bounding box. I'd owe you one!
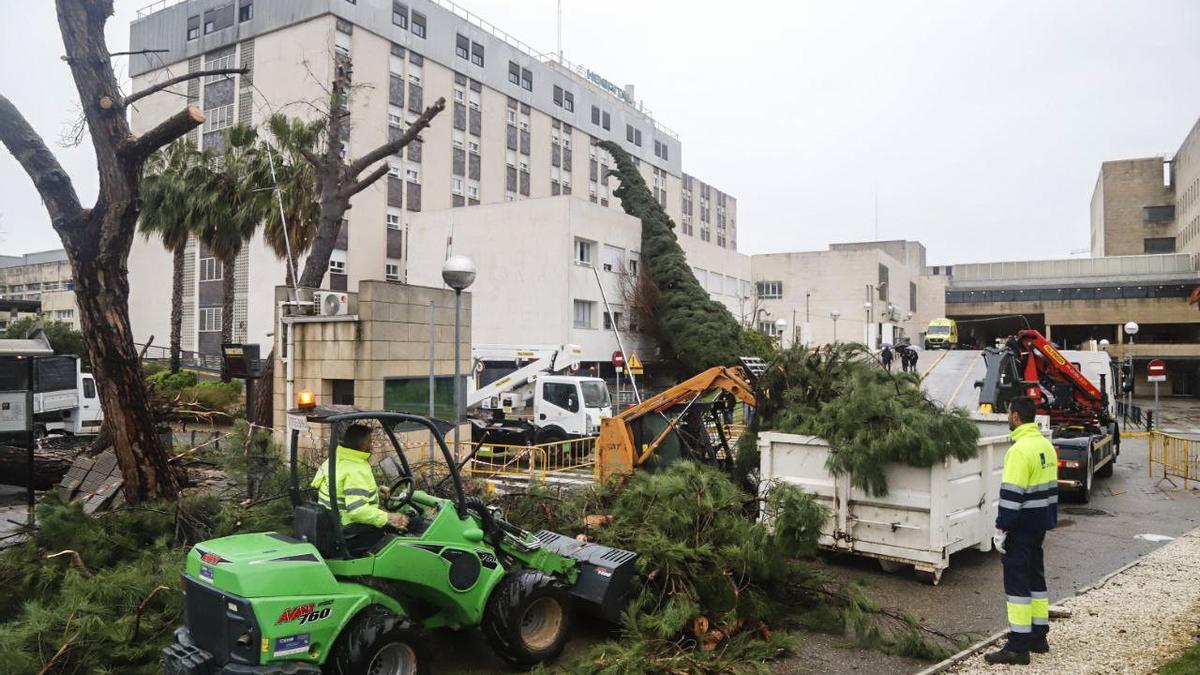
[996,422,1058,532]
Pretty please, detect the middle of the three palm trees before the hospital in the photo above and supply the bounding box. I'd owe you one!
[192,125,270,382]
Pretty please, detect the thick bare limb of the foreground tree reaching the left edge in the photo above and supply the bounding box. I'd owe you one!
[0,91,83,229]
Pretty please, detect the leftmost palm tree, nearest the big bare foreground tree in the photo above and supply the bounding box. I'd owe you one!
[139,138,199,372]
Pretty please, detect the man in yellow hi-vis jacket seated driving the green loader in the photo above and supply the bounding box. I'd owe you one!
[312,424,428,555]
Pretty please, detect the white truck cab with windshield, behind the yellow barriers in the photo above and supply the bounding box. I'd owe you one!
[534,375,612,442]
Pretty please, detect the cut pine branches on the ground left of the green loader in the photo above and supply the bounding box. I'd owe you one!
[0,441,292,675]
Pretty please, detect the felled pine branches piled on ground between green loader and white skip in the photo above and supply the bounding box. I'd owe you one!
[502,462,959,675]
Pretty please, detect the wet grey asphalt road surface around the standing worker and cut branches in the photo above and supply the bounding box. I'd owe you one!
[431,438,1200,675]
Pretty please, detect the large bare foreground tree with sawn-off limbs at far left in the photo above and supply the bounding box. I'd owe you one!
[0,0,245,503]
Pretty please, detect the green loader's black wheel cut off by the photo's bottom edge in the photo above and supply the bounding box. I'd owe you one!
[324,605,433,675]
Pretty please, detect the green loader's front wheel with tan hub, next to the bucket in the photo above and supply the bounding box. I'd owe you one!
[481,569,571,670]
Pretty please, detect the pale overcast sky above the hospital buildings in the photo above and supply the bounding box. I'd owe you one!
[0,0,1200,264]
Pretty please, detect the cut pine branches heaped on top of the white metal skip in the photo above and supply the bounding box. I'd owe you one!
[738,344,979,495]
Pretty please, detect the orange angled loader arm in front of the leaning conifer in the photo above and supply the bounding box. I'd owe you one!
[596,366,755,480]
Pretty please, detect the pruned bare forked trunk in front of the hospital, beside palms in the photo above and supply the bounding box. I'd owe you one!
[289,58,446,288]
